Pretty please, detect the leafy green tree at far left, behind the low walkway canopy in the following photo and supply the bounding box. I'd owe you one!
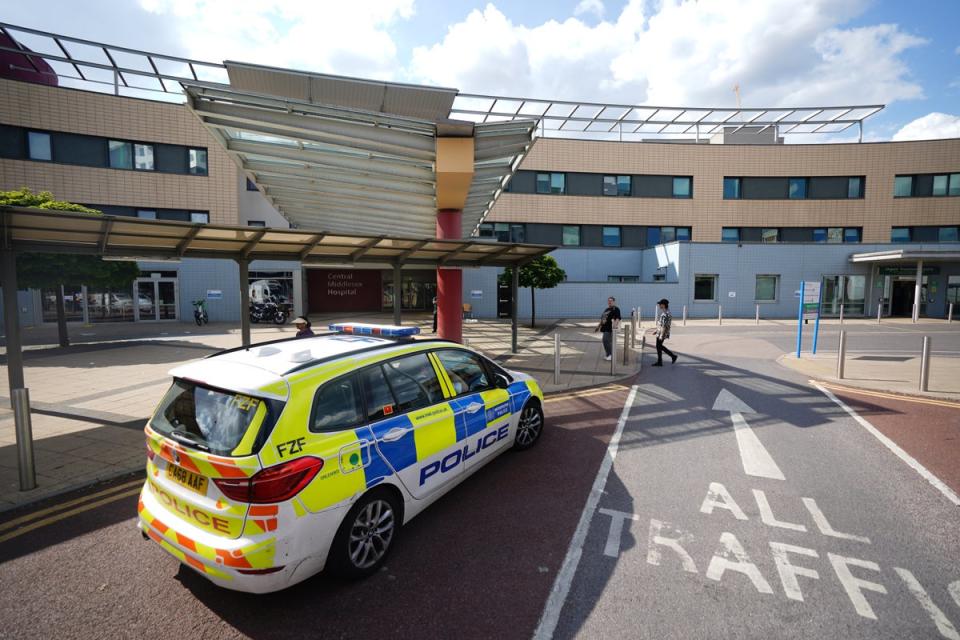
[0,188,140,347]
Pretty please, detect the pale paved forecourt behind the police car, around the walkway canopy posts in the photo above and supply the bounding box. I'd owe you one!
[0,314,635,511]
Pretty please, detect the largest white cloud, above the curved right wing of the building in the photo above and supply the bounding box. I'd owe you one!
[409,0,926,108]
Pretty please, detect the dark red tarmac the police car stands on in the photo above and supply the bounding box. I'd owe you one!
[0,385,628,640]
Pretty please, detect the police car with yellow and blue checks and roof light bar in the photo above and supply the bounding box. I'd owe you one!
[138,323,544,593]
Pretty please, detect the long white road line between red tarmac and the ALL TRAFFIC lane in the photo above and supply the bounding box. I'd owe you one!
[533,385,637,640]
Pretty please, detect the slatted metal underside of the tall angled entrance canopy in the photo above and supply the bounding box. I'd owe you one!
[183,82,535,236]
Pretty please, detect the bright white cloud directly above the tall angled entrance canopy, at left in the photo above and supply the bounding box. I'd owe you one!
[140,0,414,78]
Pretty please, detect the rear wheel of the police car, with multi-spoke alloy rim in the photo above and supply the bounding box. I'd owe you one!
[328,490,402,579]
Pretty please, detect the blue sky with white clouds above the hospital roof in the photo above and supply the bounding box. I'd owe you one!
[0,0,960,141]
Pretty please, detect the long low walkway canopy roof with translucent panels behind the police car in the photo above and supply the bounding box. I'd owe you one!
[0,207,554,267]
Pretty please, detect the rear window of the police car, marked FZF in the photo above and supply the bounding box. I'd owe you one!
[150,380,267,456]
